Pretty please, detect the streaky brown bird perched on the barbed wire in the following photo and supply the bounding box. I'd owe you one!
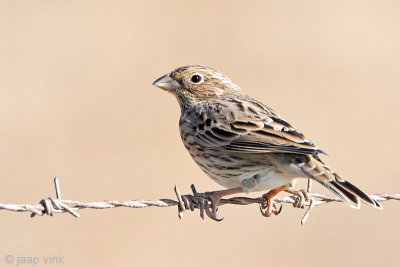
[153,65,382,220]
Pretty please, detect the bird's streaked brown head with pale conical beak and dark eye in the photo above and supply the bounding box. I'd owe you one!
[153,65,245,109]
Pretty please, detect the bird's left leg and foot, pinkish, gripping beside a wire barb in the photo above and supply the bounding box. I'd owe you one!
[192,187,243,221]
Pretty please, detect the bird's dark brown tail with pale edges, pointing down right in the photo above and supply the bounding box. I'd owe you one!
[299,156,382,209]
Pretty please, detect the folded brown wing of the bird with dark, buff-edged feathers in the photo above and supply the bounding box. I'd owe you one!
[187,99,324,155]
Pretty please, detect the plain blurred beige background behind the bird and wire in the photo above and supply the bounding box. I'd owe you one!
[0,1,400,266]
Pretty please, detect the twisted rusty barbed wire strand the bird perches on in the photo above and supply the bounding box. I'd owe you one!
[0,177,400,225]
